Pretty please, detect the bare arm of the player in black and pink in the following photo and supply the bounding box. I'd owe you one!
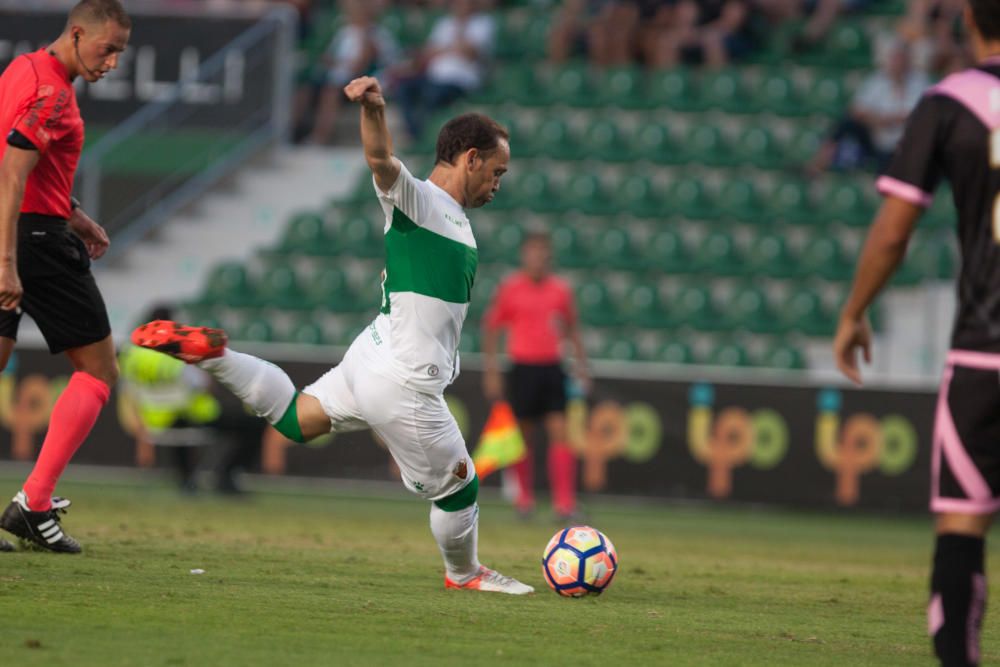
[833,196,924,385]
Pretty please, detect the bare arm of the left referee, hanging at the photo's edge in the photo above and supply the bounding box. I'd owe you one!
[0,145,39,310]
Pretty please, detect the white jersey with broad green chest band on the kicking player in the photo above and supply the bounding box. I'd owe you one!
[357,166,479,394]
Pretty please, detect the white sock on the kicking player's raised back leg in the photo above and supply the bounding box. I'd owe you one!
[198,349,298,427]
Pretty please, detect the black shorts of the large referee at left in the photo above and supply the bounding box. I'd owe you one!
[0,214,111,354]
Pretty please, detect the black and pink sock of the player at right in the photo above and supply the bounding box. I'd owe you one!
[927,534,986,667]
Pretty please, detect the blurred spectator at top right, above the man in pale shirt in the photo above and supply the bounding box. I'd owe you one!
[899,0,971,75]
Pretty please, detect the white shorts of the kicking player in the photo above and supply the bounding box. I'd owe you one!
[302,334,476,500]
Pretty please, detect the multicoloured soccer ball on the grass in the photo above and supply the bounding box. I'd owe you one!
[542,526,618,598]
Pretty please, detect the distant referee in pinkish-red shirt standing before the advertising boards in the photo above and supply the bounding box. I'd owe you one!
[483,232,590,521]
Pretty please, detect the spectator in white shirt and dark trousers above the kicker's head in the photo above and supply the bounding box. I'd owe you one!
[396,0,496,138]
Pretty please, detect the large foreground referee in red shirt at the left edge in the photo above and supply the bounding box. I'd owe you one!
[0,0,132,553]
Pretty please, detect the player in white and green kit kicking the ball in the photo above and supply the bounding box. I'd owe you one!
[139,77,534,595]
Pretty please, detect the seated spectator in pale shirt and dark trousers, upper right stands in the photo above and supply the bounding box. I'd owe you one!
[807,41,930,176]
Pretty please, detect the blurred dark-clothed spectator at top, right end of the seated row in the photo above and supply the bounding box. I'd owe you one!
[641,0,751,68]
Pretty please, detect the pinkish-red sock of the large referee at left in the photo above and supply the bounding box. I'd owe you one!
[24,371,111,512]
